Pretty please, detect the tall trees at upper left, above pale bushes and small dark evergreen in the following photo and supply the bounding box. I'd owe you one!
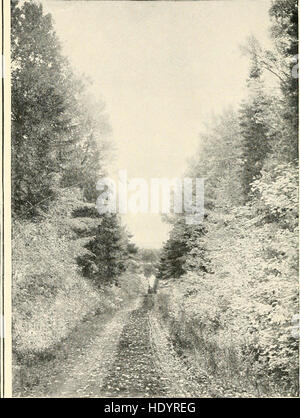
[11,1,110,219]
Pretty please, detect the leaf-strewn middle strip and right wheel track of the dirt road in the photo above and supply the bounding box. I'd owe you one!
[101,295,209,397]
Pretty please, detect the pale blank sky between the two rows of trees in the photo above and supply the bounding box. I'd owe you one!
[43,0,270,248]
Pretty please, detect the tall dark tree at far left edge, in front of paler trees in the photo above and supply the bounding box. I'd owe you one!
[11,2,71,216]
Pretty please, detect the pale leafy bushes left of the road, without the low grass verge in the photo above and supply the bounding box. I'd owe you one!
[13,190,145,363]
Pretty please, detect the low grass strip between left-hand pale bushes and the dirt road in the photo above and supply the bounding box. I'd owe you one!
[13,277,145,397]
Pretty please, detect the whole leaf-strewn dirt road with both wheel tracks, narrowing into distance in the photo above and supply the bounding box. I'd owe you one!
[20,295,209,398]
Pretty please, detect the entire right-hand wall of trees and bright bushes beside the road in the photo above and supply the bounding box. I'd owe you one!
[159,0,299,394]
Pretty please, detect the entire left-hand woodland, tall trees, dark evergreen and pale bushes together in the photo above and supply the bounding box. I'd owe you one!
[11,1,144,385]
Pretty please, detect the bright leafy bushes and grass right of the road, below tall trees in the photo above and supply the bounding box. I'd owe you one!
[160,166,299,396]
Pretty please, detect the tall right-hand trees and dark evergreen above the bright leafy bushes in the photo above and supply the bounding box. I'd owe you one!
[160,0,298,278]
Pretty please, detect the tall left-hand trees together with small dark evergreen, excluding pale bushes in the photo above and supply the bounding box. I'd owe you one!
[11,1,137,284]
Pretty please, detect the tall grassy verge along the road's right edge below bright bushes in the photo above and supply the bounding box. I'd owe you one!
[156,283,297,397]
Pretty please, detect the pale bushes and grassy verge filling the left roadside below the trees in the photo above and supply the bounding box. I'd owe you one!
[12,196,146,396]
